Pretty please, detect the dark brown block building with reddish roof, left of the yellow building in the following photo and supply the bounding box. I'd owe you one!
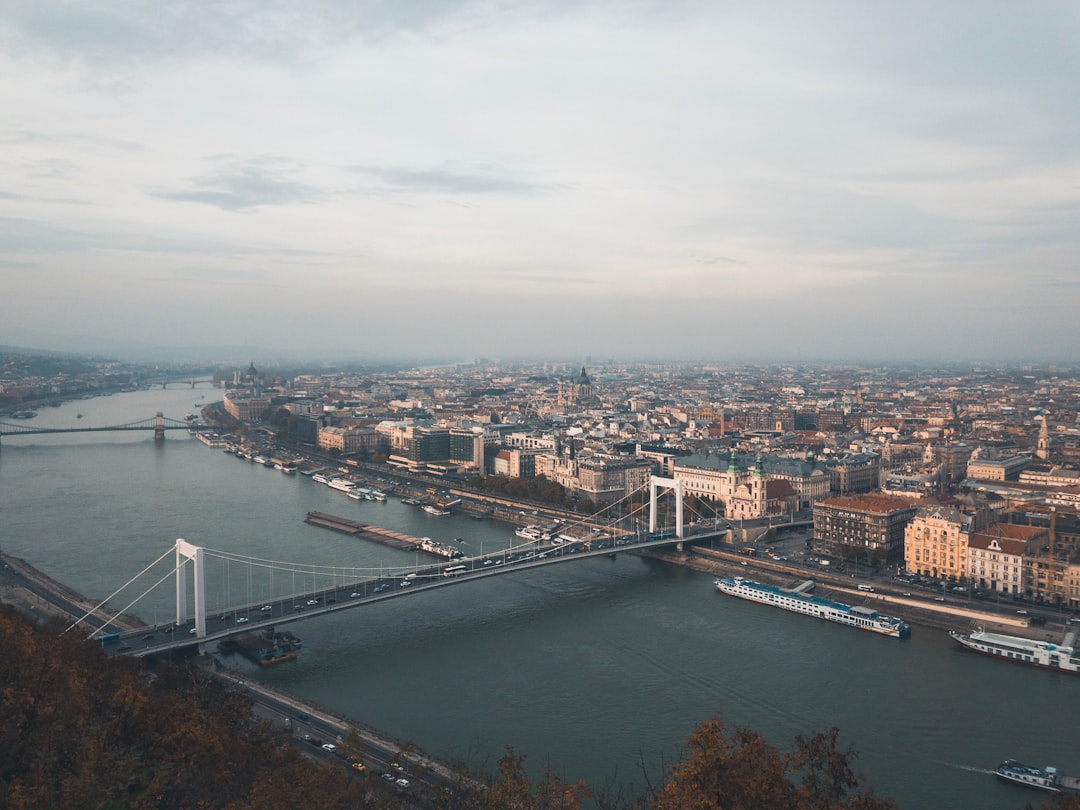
[813,495,918,565]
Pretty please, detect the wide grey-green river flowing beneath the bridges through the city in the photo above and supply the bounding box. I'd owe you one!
[0,388,1080,810]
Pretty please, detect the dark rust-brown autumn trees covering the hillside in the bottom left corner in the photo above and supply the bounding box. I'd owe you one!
[0,606,375,810]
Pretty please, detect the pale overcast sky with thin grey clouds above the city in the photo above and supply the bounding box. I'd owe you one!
[0,0,1080,362]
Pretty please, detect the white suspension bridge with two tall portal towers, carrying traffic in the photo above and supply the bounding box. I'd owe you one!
[66,476,715,656]
